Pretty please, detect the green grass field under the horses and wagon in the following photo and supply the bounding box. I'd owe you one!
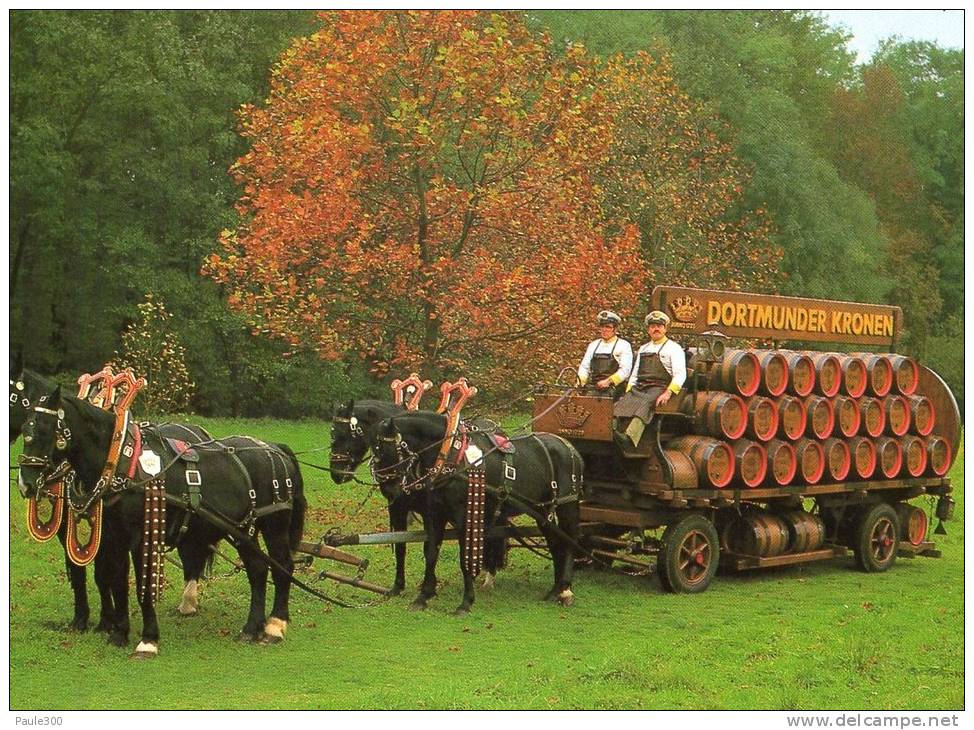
[10,419,964,710]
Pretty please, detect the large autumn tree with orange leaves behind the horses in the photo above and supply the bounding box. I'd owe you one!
[206,11,774,385]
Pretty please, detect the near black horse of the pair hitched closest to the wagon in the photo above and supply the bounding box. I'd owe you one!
[373,411,583,615]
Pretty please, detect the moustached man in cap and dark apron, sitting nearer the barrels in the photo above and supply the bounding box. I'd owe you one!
[613,310,687,446]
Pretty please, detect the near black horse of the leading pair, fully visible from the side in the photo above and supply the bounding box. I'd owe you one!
[19,389,307,658]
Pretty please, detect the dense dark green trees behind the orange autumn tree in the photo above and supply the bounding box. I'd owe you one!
[9,11,964,415]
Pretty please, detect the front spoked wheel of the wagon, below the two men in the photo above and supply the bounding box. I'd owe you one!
[658,515,720,593]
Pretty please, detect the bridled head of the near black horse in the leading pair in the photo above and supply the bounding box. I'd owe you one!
[17,386,71,497]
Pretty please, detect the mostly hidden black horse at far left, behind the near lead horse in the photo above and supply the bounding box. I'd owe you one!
[9,366,211,645]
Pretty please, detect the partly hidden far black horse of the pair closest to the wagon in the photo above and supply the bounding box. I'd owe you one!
[328,399,505,596]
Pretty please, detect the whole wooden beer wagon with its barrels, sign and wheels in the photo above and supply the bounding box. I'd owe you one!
[534,287,961,593]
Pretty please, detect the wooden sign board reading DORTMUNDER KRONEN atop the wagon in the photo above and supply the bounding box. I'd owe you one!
[651,286,903,348]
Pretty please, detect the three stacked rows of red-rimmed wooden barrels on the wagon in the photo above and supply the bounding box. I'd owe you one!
[664,350,952,488]
